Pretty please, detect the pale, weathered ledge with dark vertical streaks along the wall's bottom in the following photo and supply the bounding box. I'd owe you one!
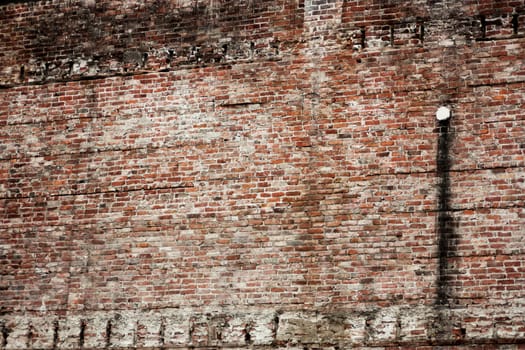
[0,303,525,350]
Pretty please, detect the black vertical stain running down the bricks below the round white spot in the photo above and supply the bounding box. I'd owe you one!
[436,118,454,305]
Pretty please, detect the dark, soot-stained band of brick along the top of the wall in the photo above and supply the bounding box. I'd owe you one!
[0,1,525,87]
